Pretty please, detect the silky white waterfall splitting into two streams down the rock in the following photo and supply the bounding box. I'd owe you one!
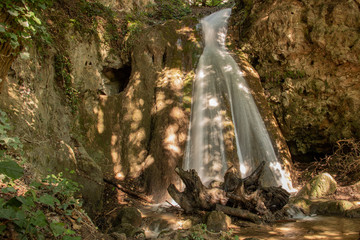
[184,9,292,190]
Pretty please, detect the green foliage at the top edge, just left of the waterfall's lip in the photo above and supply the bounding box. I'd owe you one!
[155,0,191,20]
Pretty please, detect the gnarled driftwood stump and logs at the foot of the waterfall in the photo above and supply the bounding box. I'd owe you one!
[168,162,290,222]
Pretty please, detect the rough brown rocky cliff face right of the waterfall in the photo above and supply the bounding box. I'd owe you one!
[230,0,360,159]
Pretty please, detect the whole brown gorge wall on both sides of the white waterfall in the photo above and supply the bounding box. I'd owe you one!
[0,0,360,218]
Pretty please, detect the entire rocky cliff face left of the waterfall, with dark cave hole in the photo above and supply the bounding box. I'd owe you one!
[0,1,201,216]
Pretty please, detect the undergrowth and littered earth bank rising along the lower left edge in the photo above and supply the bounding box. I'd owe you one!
[0,110,89,240]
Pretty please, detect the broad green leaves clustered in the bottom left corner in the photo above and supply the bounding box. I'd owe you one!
[0,173,81,239]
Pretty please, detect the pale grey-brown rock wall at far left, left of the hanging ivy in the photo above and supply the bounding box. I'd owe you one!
[0,43,104,216]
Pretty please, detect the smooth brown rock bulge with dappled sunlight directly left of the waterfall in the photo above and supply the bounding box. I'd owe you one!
[81,19,201,200]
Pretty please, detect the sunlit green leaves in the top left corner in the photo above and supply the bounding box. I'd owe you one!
[0,0,52,49]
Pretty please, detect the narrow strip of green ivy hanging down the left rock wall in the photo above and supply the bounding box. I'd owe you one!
[55,54,79,113]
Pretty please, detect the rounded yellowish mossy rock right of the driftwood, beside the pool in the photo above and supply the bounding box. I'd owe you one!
[296,173,337,199]
